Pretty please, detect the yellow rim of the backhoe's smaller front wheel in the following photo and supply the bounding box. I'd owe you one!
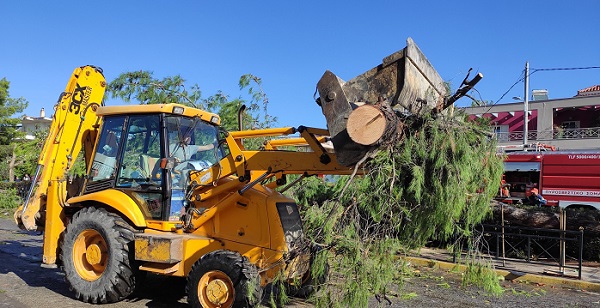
[198,271,235,307]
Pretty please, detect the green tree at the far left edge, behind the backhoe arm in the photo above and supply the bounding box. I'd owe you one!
[0,78,28,182]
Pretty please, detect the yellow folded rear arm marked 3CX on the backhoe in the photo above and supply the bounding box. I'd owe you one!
[14,66,106,263]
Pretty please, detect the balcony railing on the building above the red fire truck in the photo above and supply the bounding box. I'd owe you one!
[496,127,600,142]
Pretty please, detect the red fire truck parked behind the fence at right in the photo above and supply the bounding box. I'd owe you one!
[499,151,600,210]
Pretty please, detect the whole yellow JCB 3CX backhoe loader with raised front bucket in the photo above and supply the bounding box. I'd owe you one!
[15,39,476,307]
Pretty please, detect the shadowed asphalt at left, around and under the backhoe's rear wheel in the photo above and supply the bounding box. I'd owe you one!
[0,218,187,308]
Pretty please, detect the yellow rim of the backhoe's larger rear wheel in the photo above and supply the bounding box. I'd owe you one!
[73,229,108,281]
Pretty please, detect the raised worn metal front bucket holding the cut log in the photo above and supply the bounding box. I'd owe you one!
[317,38,449,166]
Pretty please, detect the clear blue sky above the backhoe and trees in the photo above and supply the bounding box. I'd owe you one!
[0,0,600,127]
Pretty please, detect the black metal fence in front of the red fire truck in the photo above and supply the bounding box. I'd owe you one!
[479,224,583,279]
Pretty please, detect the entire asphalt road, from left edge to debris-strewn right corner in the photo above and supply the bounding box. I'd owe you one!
[0,218,600,308]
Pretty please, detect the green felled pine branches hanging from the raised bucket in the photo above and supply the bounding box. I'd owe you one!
[286,110,502,307]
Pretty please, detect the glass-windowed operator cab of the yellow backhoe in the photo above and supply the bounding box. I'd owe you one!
[84,113,224,221]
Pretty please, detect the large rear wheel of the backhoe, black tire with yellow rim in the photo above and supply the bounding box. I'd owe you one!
[61,207,137,304]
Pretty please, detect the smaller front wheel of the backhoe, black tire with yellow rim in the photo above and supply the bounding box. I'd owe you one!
[186,250,262,308]
